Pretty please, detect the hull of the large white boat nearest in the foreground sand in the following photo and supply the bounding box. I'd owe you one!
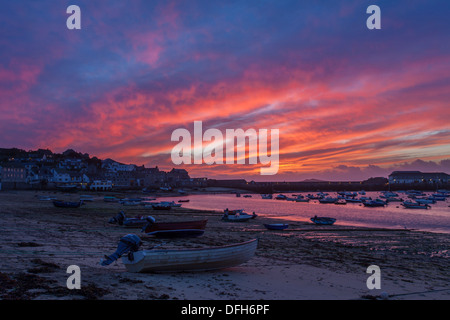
[122,239,258,273]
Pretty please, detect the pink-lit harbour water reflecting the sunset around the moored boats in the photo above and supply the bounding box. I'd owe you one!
[158,192,450,233]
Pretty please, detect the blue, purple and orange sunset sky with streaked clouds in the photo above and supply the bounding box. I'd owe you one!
[0,0,450,181]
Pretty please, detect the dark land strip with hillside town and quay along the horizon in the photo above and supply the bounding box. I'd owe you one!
[0,148,450,193]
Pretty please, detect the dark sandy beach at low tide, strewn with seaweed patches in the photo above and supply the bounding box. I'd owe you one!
[0,191,450,300]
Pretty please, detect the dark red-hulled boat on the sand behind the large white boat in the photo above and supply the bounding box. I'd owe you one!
[142,217,208,238]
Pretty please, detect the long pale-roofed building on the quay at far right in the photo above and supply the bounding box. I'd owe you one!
[389,171,450,185]
